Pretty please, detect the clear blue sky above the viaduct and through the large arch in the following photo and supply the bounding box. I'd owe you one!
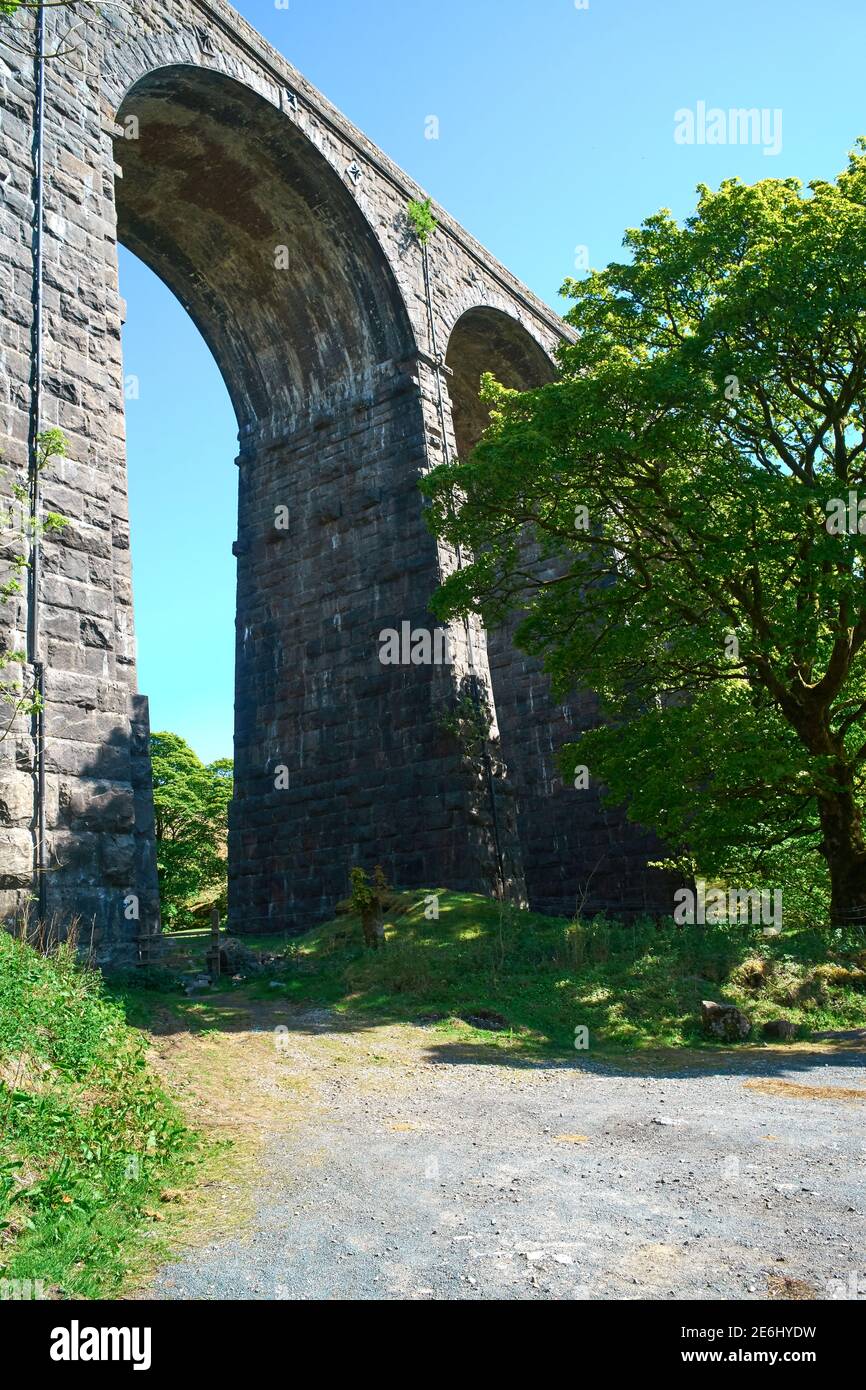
[121,0,866,759]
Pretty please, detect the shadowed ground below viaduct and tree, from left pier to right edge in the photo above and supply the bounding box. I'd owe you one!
[109,890,866,1077]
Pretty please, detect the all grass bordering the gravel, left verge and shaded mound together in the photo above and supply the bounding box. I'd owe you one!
[0,890,866,1298]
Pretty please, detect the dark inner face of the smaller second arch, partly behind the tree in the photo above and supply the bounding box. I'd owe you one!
[446,306,671,917]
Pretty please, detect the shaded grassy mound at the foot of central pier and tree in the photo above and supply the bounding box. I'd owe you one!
[225,891,866,1051]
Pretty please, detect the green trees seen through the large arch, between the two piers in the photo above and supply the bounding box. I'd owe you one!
[150,733,232,927]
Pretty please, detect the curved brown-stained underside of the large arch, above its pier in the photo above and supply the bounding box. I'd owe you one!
[114,64,413,439]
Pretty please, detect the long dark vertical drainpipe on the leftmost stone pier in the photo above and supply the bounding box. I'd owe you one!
[28,6,46,922]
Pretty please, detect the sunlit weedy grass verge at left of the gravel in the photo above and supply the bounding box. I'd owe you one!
[0,931,200,1298]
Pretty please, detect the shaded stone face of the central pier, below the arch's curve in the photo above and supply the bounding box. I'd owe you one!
[229,363,518,930]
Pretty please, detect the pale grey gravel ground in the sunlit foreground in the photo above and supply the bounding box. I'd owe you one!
[146,1009,866,1300]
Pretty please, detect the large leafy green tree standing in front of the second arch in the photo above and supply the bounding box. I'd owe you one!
[424,140,866,920]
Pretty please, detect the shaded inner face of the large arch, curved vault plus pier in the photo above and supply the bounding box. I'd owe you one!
[108,64,508,931]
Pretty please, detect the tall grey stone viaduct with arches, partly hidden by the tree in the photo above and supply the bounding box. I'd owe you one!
[0,0,670,959]
